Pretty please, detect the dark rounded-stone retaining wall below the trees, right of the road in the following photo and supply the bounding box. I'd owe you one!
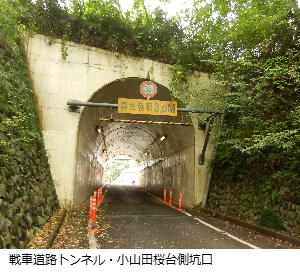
[206,180,300,234]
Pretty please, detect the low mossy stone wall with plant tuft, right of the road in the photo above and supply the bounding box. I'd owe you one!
[206,175,300,235]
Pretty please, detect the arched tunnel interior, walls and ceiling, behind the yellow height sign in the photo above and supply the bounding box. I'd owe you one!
[73,78,195,207]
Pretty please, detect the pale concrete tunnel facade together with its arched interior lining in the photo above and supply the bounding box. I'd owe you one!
[26,35,218,209]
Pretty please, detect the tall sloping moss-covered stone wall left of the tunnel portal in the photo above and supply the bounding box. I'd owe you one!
[0,5,59,248]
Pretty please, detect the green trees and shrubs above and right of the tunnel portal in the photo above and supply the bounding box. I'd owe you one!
[1,0,300,229]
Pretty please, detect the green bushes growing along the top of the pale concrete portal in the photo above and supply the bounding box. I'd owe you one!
[16,0,184,62]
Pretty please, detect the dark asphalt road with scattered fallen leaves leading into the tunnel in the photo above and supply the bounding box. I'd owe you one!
[90,184,297,249]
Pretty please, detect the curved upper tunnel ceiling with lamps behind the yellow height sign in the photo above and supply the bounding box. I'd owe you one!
[79,78,194,166]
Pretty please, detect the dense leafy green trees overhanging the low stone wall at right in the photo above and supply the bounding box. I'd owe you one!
[185,0,300,208]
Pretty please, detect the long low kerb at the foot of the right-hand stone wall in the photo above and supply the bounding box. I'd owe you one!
[201,208,300,247]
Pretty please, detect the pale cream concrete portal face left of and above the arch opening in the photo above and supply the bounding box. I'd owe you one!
[26,34,175,208]
